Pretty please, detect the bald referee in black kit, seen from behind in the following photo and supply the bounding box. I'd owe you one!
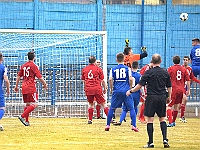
[126,54,172,148]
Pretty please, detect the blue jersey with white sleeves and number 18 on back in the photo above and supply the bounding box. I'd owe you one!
[109,64,132,92]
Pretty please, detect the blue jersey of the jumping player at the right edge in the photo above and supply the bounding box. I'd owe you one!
[190,45,200,66]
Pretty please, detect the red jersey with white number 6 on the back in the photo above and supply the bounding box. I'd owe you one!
[81,64,104,95]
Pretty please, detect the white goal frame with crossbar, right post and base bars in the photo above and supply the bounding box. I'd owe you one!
[0,29,107,117]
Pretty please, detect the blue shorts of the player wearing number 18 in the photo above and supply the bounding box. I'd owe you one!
[110,92,133,110]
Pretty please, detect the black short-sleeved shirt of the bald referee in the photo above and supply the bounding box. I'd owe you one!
[139,67,171,95]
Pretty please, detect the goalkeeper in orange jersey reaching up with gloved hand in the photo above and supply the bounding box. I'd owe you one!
[124,47,148,68]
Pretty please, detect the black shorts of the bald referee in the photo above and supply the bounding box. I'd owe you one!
[144,94,166,118]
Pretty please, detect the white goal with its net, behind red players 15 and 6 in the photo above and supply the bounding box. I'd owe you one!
[0,29,107,117]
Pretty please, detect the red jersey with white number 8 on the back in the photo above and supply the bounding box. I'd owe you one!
[168,64,190,91]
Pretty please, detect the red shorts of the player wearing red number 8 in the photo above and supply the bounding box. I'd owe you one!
[168,90,183,107]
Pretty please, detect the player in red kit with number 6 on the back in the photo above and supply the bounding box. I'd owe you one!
[81,56,109,124]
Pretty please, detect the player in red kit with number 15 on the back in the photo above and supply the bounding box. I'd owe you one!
[14,51,47,126]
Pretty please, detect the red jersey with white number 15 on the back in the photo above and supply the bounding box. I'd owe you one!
[18,61,42,94]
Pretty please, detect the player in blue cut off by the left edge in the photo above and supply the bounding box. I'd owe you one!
[0,53,10,131]
